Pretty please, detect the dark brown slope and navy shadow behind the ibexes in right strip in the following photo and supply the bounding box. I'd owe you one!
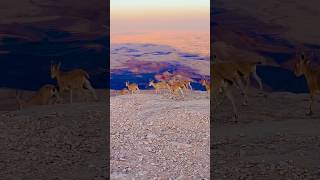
[211,0,320,92]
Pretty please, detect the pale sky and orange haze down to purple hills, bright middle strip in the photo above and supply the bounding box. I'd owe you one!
[110,0,210,54]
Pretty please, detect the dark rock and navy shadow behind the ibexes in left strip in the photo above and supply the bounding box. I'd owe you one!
[0,0,109,90]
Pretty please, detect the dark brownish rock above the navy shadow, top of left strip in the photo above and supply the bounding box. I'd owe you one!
[0,0,109,37]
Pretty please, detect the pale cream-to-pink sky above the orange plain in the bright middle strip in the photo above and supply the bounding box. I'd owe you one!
[110,0,210,34]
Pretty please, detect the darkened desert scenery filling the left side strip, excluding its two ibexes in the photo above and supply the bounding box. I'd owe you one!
[0,0,110,180]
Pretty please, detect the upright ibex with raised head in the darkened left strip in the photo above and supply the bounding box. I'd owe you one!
[51,63,98,103]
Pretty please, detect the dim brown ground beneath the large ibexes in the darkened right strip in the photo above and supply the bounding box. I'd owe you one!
[211,90,320,180]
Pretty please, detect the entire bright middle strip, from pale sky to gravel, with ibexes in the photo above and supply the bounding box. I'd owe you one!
[110,0,210,177]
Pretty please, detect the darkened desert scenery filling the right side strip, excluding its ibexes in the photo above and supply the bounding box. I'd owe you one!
[214,0,320,179]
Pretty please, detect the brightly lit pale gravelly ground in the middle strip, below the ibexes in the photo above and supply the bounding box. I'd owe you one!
[110,92,210,179]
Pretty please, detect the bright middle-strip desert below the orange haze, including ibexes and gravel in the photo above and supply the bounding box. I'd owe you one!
[110,43,210,180]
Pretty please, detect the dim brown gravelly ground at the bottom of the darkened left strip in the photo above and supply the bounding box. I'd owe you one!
[0,90,109,180]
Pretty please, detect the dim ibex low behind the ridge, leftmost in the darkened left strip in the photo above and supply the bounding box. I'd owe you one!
[16,84,61,109]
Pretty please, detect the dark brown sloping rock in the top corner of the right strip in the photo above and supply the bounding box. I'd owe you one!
[212,0,320,44]
